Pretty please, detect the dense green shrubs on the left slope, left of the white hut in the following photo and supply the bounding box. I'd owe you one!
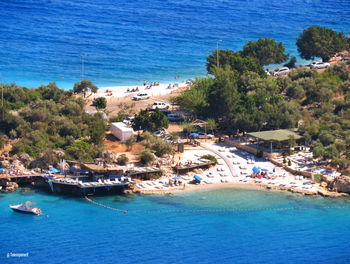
[0,83,105,167]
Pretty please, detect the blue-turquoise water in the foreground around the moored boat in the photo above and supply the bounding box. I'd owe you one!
[0,189,350,264]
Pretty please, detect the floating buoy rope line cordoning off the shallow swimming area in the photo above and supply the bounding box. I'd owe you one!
[85,196,350,214]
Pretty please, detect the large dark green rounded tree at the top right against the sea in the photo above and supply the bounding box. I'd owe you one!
[296,26,349,61]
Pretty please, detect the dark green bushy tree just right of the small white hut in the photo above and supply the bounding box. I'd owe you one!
[132,108,169,131]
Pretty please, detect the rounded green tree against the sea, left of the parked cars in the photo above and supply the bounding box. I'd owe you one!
[241,38,288,66]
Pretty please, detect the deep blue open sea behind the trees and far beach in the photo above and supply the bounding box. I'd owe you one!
[0,0,350,88]
